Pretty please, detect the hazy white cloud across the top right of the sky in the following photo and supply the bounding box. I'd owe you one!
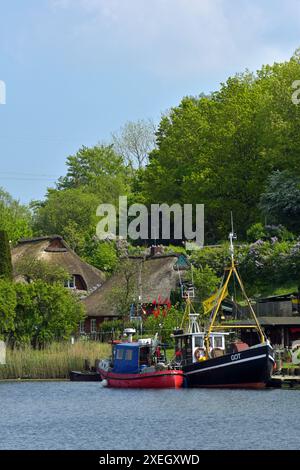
[47,0,296,78]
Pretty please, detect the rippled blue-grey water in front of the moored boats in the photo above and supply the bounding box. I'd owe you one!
[0,382,300,450]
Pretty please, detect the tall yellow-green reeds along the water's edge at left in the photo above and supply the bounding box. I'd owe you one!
[0,341,111,380]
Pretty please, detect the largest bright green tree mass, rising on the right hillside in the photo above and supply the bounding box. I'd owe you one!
[135,52,300,242]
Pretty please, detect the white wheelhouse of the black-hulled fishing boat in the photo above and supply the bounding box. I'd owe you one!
[173,330,229,365]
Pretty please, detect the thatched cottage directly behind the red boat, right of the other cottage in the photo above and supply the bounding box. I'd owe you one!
[81,253,189,333]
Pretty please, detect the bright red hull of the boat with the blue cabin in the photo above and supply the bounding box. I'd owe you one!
[99,369,184,388]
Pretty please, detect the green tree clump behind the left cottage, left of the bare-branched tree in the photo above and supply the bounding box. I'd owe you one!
[32,145,130,257]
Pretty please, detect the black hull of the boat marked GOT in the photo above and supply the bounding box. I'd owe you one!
[182,344,274,388]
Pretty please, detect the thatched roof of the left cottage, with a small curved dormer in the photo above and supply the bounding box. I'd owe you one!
[12,235,105,290]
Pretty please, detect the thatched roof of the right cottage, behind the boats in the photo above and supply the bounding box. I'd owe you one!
[83,254,189,317]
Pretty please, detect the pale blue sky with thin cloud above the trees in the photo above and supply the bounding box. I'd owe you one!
[0,0,300,203]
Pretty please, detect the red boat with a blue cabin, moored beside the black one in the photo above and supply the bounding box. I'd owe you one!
[99,339,184,388]
